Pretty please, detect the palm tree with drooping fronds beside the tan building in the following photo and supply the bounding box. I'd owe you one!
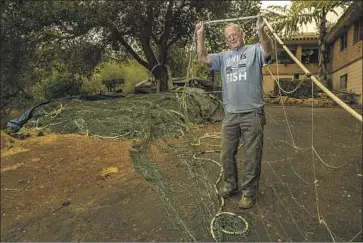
[270,0,352,89]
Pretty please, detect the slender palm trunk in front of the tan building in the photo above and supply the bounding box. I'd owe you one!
[319,10,332,89]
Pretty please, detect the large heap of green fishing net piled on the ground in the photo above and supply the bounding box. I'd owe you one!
[14,88,223,139]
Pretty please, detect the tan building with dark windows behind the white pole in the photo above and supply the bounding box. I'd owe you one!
[263,1,363,104]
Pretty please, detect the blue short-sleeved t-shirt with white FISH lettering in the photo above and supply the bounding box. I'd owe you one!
[211,43,265,113]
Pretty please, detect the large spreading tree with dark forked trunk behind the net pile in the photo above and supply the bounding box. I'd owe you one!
[37,0,259,91]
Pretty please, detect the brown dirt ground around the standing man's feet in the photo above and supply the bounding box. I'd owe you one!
[1,106,362,242]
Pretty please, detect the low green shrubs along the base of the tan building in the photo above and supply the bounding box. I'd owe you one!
[273,78,319,99]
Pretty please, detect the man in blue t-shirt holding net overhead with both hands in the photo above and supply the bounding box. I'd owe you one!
[196,17,272,209]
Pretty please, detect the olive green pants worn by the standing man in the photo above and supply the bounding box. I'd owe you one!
[221,108,266,197]
